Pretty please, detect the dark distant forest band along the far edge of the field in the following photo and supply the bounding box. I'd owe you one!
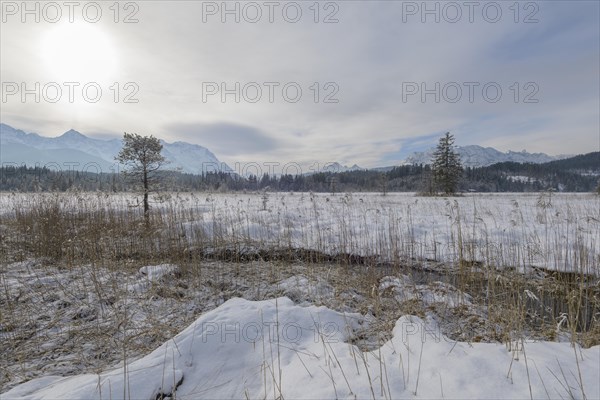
[0,152,600,194]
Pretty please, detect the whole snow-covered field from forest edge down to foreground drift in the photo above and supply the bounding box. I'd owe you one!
[0,193,600,399]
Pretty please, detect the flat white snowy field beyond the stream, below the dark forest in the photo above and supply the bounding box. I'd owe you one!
[0,193,600,275]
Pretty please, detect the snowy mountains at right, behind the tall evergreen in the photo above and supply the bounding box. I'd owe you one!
[404,145,569,167]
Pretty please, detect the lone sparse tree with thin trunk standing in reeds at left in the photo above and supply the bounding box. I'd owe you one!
[115,132,167,220]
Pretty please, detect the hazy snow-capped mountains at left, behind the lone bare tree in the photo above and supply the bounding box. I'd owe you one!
[0,124,232,174]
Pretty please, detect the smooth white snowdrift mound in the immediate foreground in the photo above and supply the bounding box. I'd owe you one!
[2,297,600,400]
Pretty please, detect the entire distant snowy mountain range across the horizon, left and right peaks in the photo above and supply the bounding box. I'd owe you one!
[0,124,569,174]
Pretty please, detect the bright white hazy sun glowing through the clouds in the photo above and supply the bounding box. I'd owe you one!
[42,23,116,82]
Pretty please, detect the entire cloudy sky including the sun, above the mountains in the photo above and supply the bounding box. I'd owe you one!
[0,1,600,167]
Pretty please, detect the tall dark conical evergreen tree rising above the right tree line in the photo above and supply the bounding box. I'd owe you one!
[431,132,463,195]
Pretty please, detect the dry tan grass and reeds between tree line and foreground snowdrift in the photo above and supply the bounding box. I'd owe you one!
[0,193,600,394]
